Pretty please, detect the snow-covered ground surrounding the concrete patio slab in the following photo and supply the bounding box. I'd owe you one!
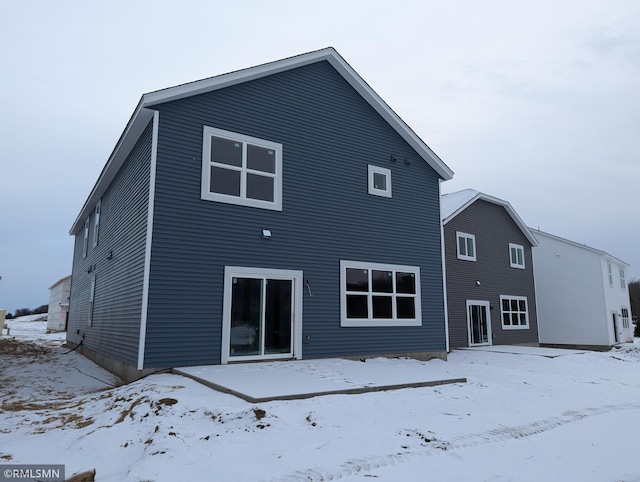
[0,318,640,482]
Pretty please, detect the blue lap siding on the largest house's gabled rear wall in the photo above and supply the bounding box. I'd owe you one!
[145,62,445,367]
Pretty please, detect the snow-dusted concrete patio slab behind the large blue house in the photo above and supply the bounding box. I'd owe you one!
[173,358,466,403]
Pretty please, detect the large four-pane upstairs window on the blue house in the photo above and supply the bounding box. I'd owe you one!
[201,126,282,211]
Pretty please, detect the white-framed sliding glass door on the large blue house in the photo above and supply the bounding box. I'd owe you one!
[222,266,302,363]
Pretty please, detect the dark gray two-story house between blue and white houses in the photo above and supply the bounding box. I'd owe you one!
[441,189,538,348]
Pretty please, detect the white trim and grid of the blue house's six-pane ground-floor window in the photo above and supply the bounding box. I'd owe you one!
[340,260,422,327]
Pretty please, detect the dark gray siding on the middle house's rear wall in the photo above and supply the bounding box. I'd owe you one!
[444,200,538,348]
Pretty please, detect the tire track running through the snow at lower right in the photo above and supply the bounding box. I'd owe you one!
[268,403,640,482]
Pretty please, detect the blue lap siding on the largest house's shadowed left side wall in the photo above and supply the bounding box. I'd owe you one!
[67,120,152,366]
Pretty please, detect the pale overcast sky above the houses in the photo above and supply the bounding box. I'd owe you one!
[0,0,640,312]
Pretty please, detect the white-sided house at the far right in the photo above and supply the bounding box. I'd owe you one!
[531,229,633,349]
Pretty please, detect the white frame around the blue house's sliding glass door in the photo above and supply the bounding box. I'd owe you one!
[220,266,304,364]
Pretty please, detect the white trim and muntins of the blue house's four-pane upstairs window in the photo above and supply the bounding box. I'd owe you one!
[200,126,282,211]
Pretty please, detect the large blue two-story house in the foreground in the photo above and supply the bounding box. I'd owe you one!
[67,48,453,379]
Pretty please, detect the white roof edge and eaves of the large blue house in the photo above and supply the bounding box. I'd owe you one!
[70,47,453,234]
